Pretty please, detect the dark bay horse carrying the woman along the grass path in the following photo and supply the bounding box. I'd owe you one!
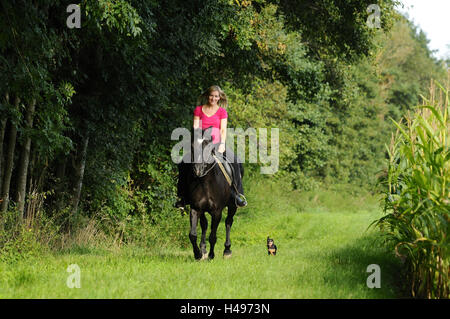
[185,128,244,260]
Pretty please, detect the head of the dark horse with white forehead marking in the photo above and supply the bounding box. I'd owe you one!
[192,126,214,177]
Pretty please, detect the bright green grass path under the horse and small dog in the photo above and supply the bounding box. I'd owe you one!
[0,182,400,299]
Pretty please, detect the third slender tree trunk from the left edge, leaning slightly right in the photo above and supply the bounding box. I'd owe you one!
[16,99,36,218]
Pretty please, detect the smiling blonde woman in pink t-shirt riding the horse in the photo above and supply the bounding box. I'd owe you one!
[175,85,247,209]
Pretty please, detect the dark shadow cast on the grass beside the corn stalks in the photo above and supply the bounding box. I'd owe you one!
[323,234,408,299]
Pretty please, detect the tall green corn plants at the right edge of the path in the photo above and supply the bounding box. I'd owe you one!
[375,79,450,298]
